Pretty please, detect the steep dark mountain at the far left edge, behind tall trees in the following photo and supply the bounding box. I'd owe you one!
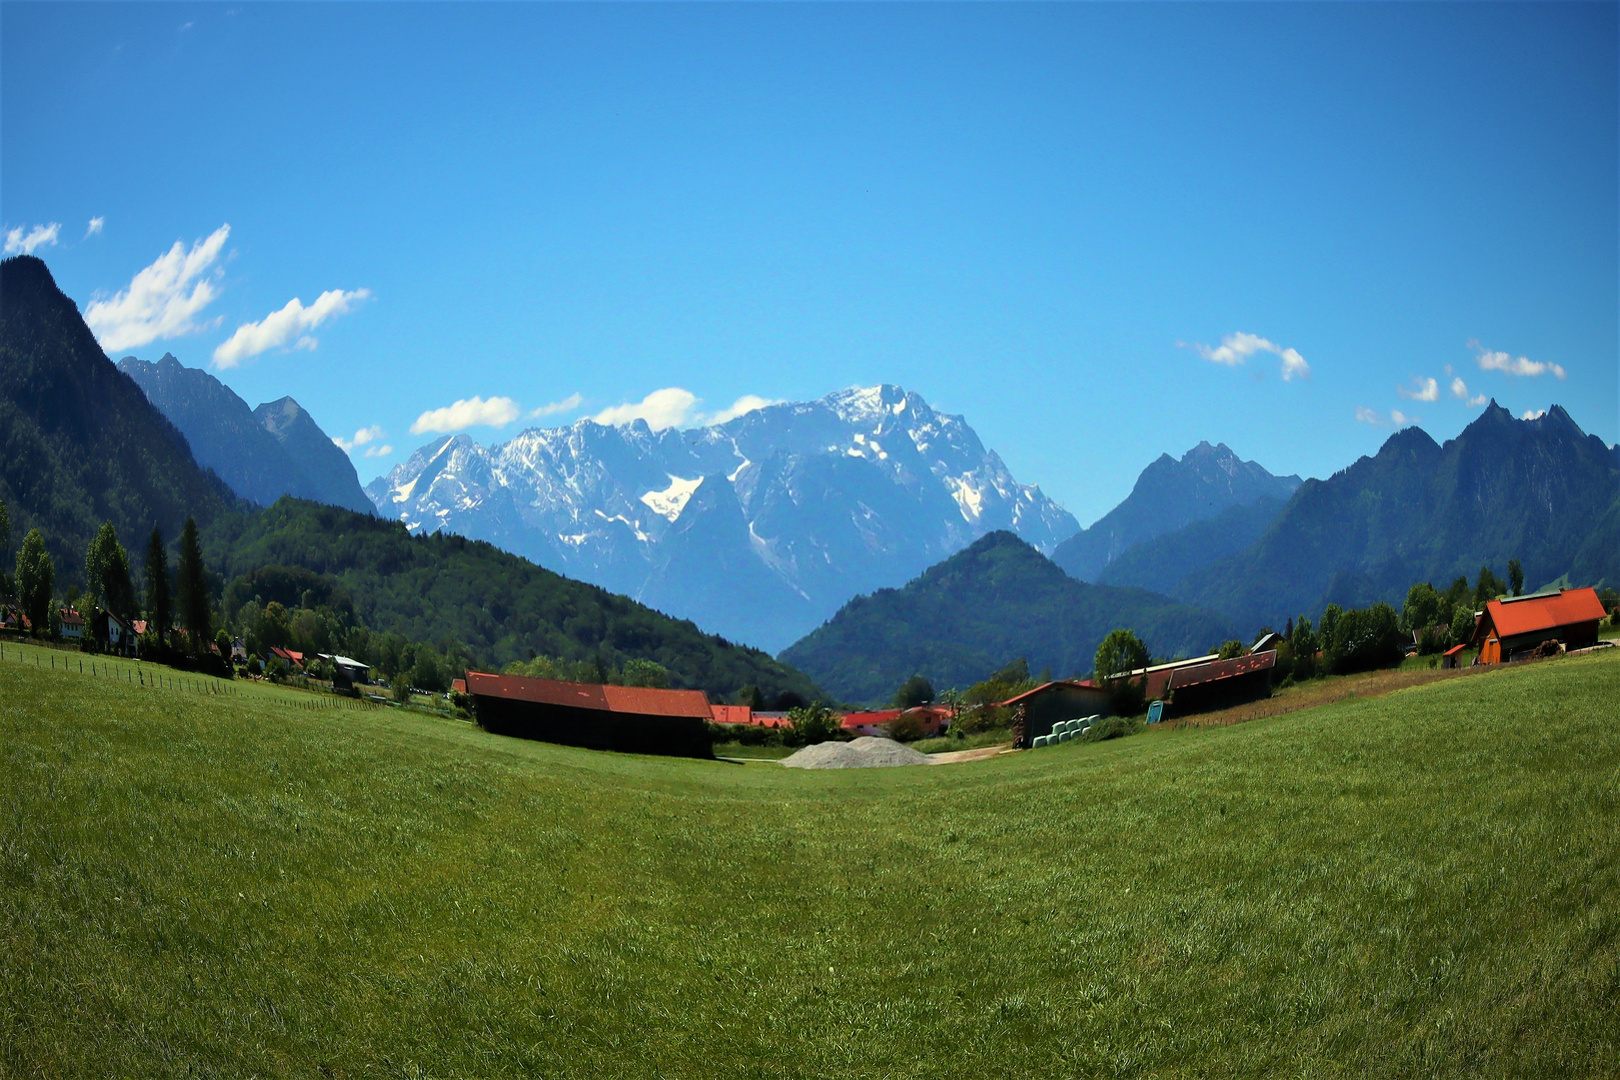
[0,256,237,581]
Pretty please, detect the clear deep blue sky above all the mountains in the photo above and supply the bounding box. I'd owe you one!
[0,3,1620,523]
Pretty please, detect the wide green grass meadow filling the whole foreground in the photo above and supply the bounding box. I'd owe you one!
[0,656,1620,1077]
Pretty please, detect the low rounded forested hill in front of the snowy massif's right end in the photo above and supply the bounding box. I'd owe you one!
[781,533,1233,701]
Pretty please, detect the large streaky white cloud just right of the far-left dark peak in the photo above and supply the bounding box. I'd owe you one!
[84,225,230,351]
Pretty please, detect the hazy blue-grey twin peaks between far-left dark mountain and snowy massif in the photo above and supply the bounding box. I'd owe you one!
[118,353,371,513]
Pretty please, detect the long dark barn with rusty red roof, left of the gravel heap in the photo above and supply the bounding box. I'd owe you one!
[467,672,714,758]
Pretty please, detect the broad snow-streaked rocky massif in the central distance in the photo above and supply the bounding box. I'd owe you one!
[366,385,1079,651]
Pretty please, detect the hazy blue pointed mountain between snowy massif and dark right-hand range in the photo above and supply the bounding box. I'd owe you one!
[1051,442,1299,581]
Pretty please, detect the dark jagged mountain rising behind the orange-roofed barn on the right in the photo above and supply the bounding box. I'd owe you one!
[1175,402,1620,625]
